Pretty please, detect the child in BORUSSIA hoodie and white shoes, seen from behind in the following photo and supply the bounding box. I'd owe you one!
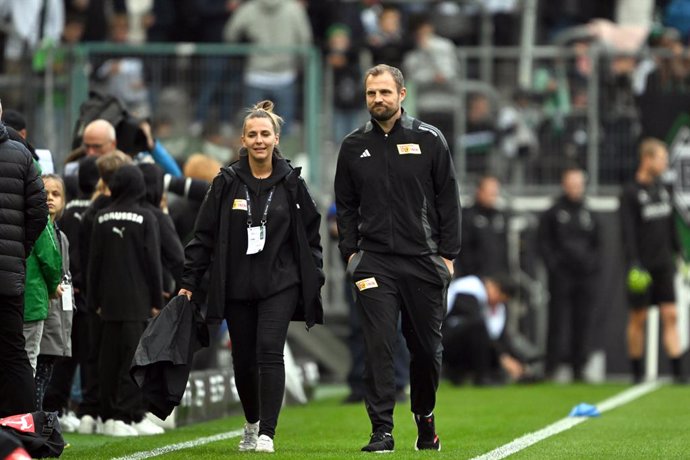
[87,165,163,436]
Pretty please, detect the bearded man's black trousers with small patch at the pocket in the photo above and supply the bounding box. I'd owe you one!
[348,251,450,433]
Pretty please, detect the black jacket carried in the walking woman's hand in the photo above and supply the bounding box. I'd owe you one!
[129,296,209,420]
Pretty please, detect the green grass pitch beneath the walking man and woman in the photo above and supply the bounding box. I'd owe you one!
[61,384,690,460]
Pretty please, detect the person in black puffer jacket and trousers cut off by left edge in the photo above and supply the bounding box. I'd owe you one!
[0,105,48,417]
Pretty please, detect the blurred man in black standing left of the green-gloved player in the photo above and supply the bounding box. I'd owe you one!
[538,167,600,380]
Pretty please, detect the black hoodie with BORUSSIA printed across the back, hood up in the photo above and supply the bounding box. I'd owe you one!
[87,165,163,321]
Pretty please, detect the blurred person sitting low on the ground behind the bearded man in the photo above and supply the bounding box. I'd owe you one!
[442,275,531,385]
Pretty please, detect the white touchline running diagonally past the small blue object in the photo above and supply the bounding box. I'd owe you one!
[472,381,661,460]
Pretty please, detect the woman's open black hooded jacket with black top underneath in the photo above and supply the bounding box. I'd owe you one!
[181,151,324,327]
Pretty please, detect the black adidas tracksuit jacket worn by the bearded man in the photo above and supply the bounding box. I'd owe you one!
[335,111,460,260]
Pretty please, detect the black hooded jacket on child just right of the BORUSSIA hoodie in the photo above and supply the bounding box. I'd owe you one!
[139,163,184,287]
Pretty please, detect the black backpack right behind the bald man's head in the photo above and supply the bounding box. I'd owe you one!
[72,90,148,155]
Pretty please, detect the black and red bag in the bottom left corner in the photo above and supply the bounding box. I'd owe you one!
[0,411,65,458]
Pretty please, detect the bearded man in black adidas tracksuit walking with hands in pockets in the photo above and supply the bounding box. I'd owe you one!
[335,64,460,452]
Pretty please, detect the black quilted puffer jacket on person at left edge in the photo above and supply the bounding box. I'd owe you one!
[0,123,48,296]
